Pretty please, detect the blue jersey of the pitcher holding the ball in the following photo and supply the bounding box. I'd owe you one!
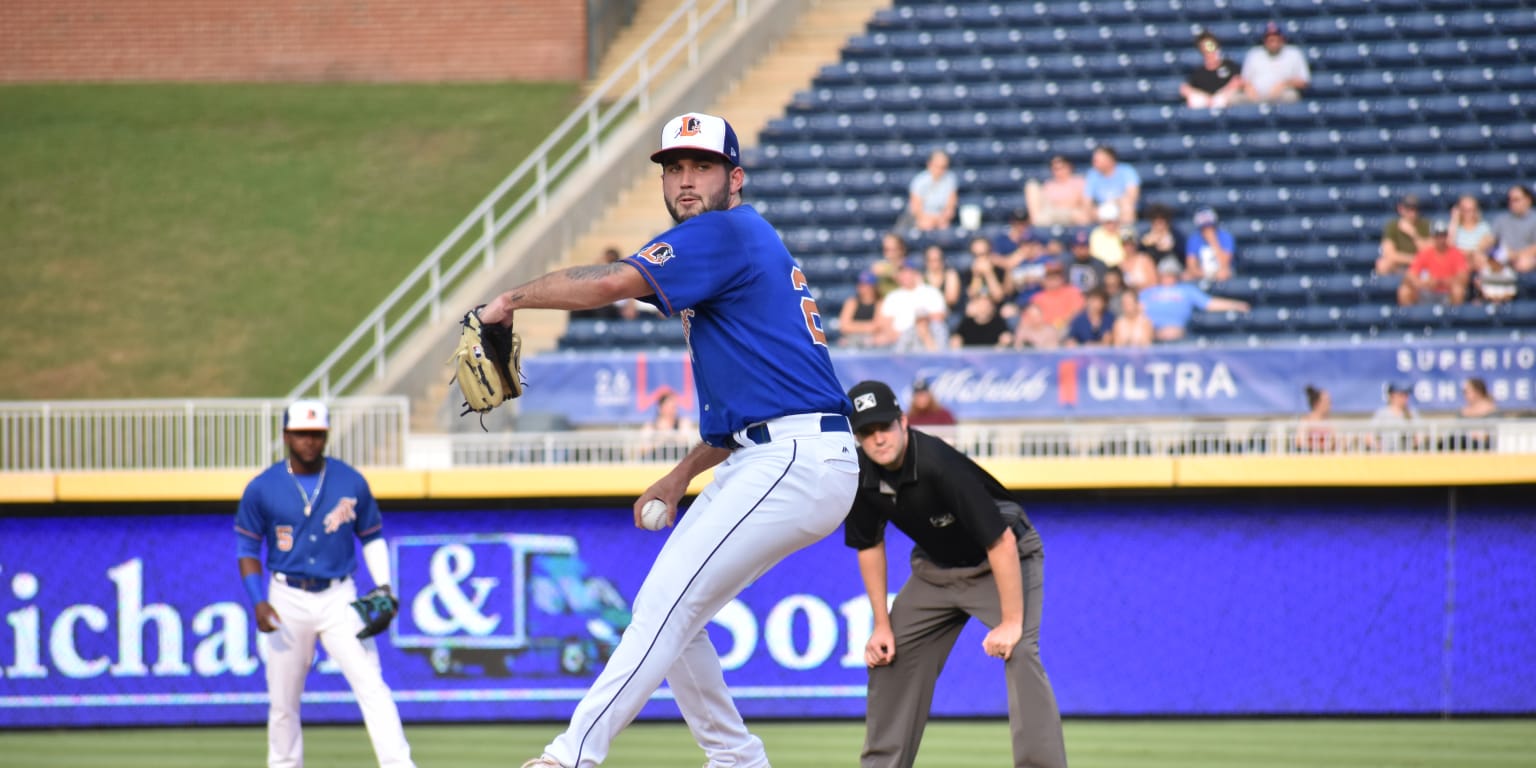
[625,206,849,445]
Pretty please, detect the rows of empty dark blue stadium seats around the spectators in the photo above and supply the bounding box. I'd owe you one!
[562,0,1536,349]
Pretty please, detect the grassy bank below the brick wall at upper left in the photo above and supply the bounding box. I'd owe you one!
[0,83,581,399]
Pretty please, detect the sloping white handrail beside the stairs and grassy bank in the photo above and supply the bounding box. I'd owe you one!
[289,0,750,398]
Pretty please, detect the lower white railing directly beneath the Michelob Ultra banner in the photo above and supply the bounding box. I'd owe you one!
[433,419,1536,467]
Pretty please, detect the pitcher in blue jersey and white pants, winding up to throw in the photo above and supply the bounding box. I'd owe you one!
[479,112,859,768]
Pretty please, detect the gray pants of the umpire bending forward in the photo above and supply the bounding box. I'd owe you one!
[860,553,1066,768]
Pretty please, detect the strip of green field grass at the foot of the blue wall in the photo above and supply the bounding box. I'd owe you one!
[0,720,1536,768]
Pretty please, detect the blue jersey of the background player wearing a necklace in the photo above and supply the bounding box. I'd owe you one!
[235,458,384,579]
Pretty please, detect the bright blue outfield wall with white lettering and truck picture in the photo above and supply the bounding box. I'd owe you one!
[0,488,1536,727]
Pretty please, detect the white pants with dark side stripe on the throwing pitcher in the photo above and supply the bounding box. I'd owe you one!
[544,427,859,768]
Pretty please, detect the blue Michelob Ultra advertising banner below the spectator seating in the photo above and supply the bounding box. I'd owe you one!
[519,341,1536,425]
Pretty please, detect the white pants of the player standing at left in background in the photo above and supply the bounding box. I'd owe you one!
[267,578,415,768]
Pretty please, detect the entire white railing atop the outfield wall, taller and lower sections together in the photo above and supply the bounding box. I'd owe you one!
[9,408,1536,472]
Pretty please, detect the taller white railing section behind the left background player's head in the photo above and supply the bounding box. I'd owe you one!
[0,396,410,472]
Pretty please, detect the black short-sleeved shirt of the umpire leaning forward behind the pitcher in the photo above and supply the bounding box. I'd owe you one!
[843,429,1040,568]
